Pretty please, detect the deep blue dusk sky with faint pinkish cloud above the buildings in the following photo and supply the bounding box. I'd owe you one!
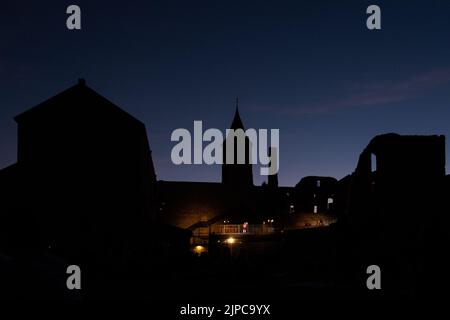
[0,0,450,186]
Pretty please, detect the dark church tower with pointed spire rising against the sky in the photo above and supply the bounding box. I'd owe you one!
[222,98,253,190]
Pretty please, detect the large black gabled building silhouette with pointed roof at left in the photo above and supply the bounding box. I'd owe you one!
[0,80,164,295]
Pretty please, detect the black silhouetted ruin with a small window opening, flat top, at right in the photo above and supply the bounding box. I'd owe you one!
[342,134,448,295]
